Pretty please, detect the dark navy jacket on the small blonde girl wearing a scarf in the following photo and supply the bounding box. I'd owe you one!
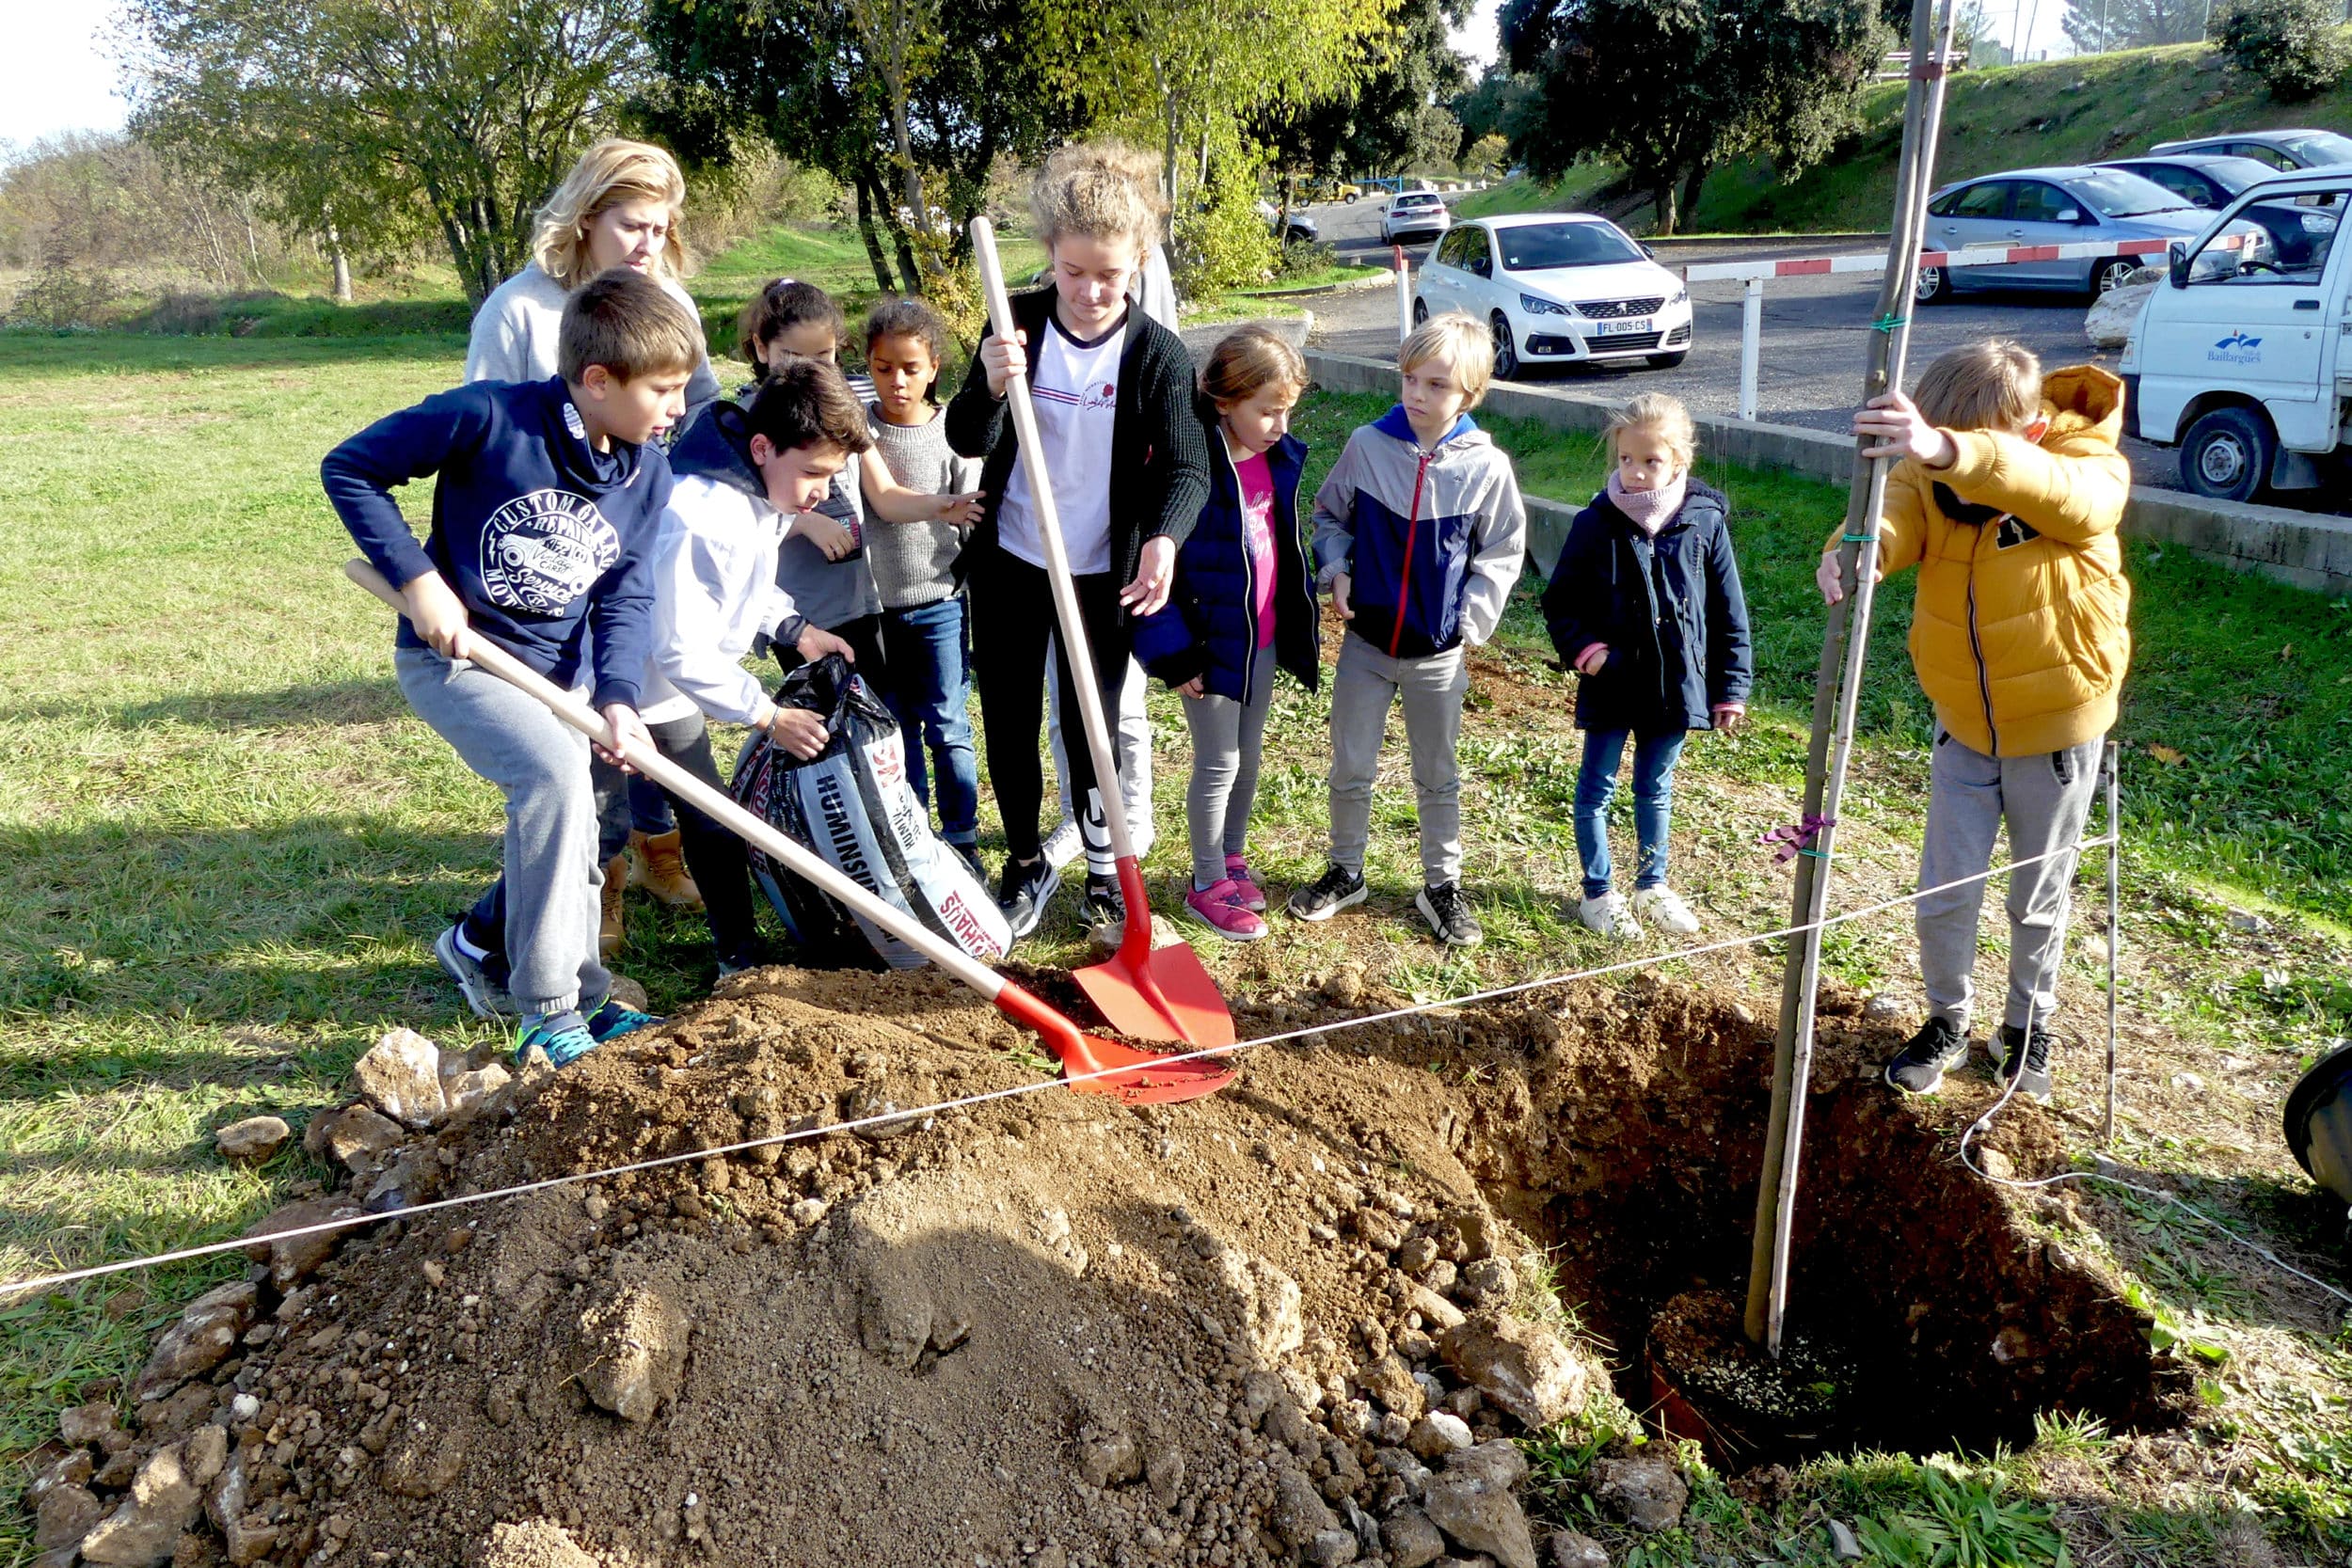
[1543,480,1755,736]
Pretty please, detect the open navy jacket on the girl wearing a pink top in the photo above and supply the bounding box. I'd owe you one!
[1136,422,1322,703]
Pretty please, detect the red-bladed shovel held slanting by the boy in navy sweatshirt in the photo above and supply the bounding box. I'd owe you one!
[343,562,1232,1105]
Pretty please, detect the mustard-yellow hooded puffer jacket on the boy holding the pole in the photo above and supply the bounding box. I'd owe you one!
[1880,364,2131,757]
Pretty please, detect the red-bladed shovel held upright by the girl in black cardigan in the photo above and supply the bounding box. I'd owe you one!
[972,218,1232,1046]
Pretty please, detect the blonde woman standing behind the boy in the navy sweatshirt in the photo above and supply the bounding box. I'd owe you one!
[466,136,720,957]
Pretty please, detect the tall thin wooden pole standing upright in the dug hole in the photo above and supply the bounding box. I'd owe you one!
[1745,0,1957,1356]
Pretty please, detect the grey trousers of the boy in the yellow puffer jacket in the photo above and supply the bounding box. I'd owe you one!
[1919,731,2106,1035]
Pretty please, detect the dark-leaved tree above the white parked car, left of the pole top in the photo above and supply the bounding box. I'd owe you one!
[1501,0,1886,235]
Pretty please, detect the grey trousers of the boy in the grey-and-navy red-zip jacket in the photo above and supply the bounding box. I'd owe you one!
[1331,632,1470,886]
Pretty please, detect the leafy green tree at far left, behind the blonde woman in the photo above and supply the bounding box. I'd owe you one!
[118,0,643,303]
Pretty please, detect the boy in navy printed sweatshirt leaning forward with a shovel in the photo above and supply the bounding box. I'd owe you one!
[320,268,704,1065]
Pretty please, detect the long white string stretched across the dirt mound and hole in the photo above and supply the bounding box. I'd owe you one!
[0,830,2117,1300]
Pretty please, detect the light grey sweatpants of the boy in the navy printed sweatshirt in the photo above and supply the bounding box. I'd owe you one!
[393,649,612,1013]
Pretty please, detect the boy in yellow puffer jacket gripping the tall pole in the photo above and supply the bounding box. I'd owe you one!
[1819,341,2131,1101]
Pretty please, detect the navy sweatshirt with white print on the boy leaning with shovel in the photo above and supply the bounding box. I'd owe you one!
[320,378,671,707]
